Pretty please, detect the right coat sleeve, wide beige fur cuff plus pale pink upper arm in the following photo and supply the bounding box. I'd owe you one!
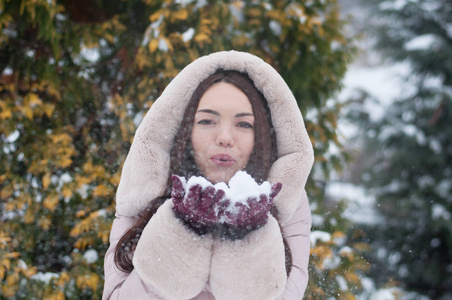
[210,193,311,300]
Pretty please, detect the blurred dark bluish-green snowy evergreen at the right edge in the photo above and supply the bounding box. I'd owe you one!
[353,0,452,299]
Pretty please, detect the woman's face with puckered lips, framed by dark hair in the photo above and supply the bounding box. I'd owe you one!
[191,82,254,183]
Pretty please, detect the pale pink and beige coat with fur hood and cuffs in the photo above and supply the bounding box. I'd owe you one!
[103,51,313,300]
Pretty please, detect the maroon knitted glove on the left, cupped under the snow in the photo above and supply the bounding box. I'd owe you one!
[171,175,225,234]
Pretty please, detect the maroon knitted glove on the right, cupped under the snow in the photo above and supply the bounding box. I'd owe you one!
[221,183,282,231]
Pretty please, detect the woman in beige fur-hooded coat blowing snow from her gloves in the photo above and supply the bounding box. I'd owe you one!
[103,51,313,300]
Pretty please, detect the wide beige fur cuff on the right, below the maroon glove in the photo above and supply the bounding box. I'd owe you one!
[210,216,287,300]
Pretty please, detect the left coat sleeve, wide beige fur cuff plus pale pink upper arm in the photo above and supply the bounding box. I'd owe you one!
[102,201,212,299]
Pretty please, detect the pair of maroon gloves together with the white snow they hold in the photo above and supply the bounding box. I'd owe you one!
[171,171,282,239]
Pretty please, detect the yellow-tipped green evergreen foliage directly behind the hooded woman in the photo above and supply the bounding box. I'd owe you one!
[0,0,357,299]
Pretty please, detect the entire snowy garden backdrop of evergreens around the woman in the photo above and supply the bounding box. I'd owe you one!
[0,0,452,299]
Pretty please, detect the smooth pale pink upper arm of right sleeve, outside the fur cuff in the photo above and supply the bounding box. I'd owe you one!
[280,193,311,300]
